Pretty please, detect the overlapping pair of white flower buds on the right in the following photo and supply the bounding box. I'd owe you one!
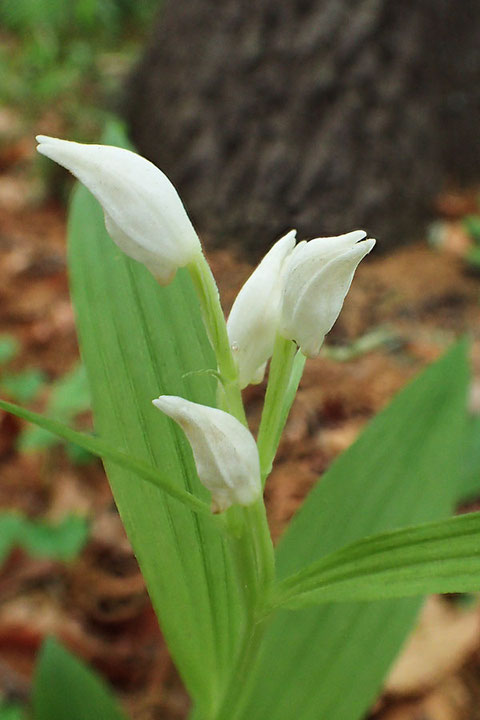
[227,230,375,387]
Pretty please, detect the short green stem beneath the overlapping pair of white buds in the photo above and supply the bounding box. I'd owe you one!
[257,335,306,485]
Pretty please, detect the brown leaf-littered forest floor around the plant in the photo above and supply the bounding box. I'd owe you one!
[0,115,480,720]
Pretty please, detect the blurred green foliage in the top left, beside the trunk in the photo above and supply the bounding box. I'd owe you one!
[0,0,161,139]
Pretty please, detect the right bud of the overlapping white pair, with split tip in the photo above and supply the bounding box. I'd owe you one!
[280,230,375,357]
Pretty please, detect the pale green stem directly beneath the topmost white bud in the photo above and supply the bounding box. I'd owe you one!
[187,253,247,425]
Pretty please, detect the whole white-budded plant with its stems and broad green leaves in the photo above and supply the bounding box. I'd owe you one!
[0,121,480,720]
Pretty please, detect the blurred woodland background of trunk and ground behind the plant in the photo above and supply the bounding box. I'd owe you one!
[0,0,480,720]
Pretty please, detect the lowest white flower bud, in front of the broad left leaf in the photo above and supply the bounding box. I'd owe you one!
[153,395,262,512]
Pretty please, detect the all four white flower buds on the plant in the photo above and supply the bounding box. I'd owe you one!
[37,135,375,512]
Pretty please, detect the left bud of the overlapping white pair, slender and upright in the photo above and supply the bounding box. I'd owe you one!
[227,230,296,388]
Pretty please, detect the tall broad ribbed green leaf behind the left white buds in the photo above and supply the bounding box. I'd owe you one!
[69,121,244,714]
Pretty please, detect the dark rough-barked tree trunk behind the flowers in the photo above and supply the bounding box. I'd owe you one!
[125,0,480,256]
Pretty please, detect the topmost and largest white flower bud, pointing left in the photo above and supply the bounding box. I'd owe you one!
[37,135,201,284]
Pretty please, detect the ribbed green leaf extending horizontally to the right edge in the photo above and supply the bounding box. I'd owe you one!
[273,513,480,608]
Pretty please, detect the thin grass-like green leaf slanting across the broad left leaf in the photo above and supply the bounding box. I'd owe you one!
[0,400,212,518]
